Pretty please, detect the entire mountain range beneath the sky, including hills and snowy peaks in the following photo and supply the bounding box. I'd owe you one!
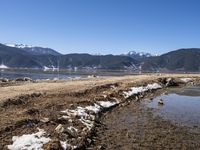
[0,44,200,72]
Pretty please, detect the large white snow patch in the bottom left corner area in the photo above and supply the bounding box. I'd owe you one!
[8,129,51,150]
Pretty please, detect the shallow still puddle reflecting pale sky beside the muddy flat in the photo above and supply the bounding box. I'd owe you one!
[145,86,200,127]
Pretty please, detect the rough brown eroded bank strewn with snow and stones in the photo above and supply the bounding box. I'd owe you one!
[0,78,198,149]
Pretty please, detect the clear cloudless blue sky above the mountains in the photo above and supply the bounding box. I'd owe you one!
[0,0,200,54]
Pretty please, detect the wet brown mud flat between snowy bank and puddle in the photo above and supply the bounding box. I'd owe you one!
[88,91,200,150]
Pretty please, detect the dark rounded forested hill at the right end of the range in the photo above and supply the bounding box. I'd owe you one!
[141,48,200,71]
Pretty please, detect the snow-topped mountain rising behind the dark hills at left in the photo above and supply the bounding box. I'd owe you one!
[5,44,61,56]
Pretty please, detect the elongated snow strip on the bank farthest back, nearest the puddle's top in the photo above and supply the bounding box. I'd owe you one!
[124,83,162,98]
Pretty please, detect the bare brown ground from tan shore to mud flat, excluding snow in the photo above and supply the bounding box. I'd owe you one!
[0,74,200,149]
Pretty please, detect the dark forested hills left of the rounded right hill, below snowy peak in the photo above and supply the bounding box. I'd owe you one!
[0,44,138,70]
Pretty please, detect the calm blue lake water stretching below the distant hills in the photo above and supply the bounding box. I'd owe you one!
[0,69,137,79]
